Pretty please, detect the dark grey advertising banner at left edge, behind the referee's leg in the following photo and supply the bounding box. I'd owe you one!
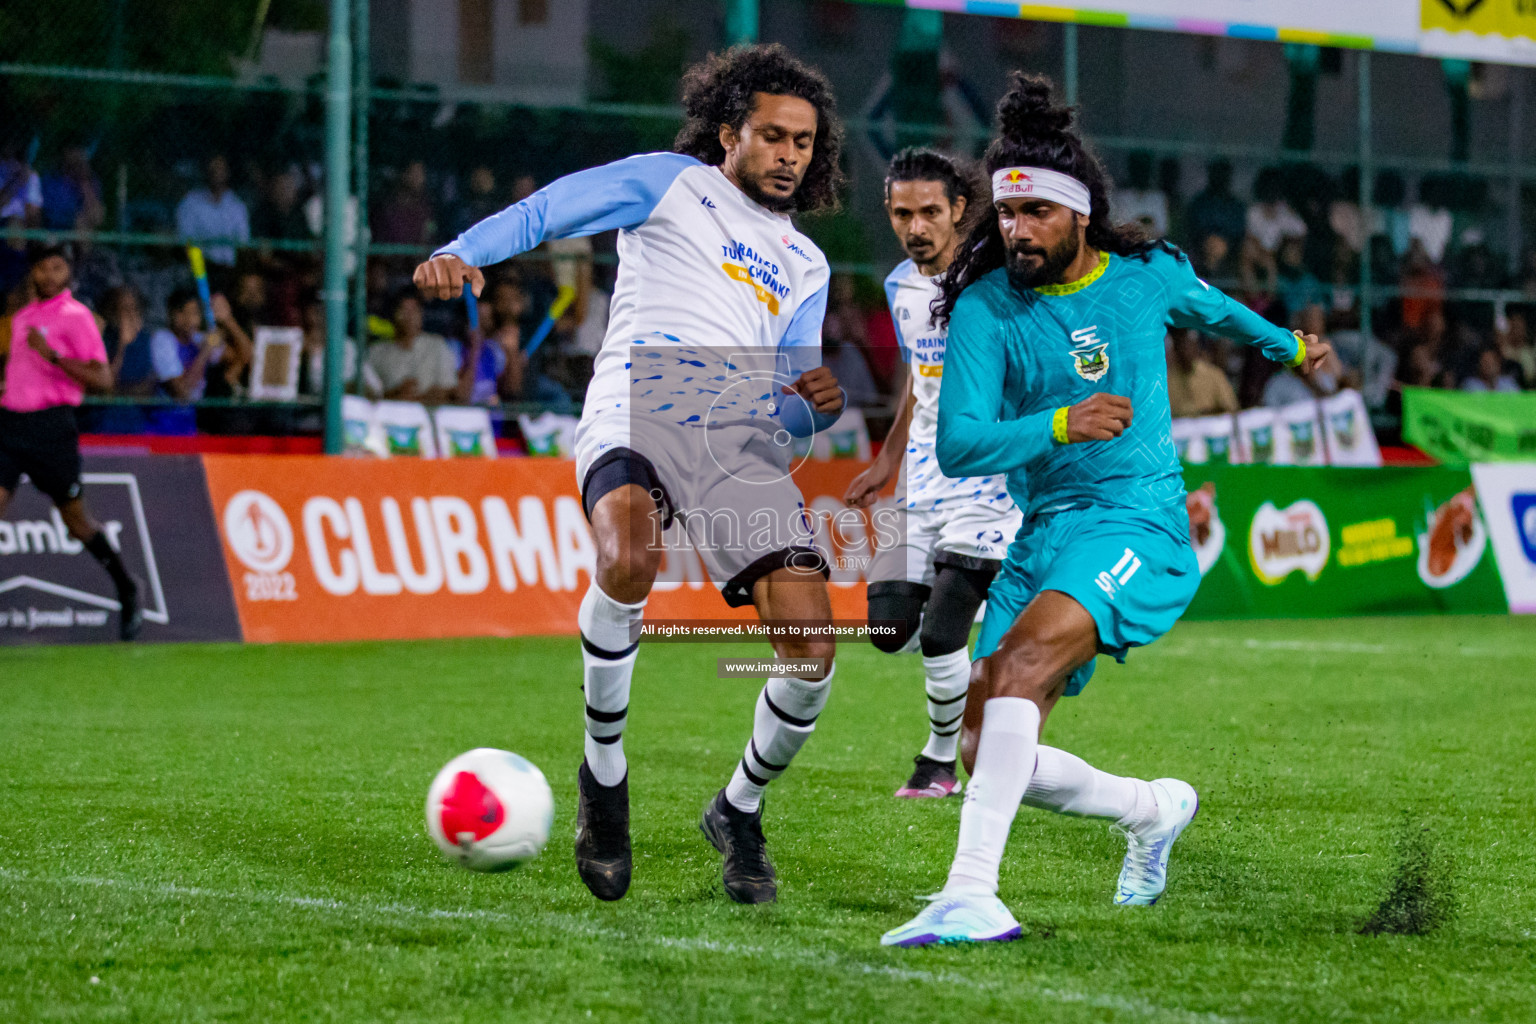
[0,456,240,643]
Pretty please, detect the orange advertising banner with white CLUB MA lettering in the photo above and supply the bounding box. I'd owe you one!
[203,456,871,642]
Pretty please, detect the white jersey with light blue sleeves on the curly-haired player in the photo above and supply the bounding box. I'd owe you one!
[439,154,831,422]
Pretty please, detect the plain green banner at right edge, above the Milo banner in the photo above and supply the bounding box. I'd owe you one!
[1402,387,1536,465]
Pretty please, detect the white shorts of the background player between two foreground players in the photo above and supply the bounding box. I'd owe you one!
[868,502,1025,586]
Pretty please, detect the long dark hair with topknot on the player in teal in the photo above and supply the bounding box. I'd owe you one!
[932,71,1177,327]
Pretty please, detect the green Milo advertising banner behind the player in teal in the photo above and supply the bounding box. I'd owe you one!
[1184,465,1508,619]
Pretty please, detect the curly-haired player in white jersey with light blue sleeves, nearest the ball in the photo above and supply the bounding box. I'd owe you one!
[415,45,846,903]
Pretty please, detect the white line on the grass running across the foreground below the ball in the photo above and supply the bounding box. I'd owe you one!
[0,867,1240,1024]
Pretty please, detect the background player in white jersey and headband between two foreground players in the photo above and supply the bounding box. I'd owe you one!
[845,149,1021,798]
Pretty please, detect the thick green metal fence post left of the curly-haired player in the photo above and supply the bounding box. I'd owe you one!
[323,0,351,454]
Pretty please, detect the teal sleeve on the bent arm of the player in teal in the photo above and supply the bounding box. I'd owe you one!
[934,296,1058,477]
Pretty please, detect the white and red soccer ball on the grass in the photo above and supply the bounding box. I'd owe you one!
[427,746,554,870]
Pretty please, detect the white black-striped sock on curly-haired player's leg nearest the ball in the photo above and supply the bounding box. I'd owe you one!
[576,583,645,786]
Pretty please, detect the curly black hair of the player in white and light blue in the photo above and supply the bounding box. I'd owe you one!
[673,43,843,212]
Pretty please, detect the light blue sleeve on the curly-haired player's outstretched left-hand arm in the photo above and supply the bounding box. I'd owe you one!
[432,154,699,267]
